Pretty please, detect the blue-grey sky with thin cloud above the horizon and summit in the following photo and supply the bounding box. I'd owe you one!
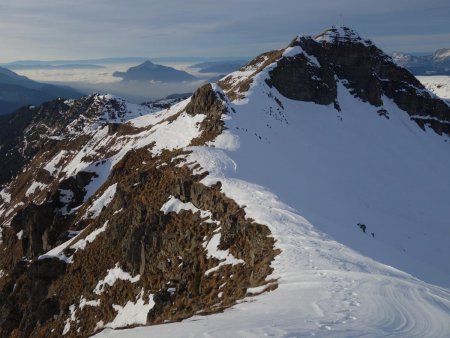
[0,0,450,62]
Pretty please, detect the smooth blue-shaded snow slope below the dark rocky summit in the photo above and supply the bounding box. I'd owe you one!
[210,78,450,287]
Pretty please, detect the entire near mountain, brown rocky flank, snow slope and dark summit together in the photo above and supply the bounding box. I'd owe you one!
[0,27,450,337]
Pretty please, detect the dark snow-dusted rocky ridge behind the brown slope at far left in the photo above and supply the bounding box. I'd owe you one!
[0,94,186,186]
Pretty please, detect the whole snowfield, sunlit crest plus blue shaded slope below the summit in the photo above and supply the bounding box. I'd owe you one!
[96,62,450,337]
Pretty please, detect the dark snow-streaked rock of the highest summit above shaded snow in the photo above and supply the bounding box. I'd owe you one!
[219,27,450,134]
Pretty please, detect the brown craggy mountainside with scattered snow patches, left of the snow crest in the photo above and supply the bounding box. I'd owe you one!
[0,85,277,337]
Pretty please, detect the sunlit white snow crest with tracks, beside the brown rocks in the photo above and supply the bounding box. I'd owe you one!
[98,157,450,337]
